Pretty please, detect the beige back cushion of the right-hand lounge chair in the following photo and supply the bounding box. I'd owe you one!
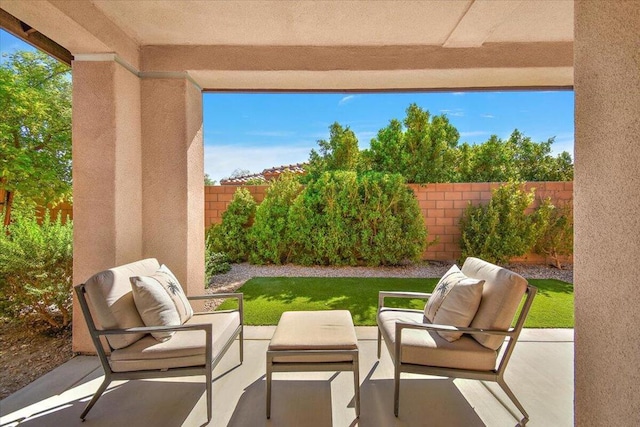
[462,257,527,350]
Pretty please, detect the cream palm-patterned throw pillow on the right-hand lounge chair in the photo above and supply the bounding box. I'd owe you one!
[424,265,484,342]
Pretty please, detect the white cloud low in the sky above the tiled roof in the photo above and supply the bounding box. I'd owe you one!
[204,143,315,183]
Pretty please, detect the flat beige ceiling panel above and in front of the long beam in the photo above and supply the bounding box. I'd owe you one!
[87,0,573,47]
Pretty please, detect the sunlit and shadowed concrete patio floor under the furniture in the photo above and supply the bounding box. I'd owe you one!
[0,327,573,427]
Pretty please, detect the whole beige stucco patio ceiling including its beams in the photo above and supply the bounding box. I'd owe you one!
[2,0,574,90]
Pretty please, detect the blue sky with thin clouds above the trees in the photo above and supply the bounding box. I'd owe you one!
[0,30,574,182]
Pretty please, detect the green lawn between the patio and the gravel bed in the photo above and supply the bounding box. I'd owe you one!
[220,277,573,328]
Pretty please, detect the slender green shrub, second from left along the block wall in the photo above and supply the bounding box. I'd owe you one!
[249,174,302,264]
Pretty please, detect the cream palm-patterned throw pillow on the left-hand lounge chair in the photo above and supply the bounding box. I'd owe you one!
[129,265,193,341]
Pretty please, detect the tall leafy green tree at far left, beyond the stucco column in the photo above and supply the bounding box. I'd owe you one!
[0,51,71,224]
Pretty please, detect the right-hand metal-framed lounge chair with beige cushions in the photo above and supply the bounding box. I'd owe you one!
[377,257,537,425]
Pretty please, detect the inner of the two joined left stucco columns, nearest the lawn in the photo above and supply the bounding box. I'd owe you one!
[142,76,204,295]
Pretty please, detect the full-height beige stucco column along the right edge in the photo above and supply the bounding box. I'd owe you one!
[574,0,640,426]
